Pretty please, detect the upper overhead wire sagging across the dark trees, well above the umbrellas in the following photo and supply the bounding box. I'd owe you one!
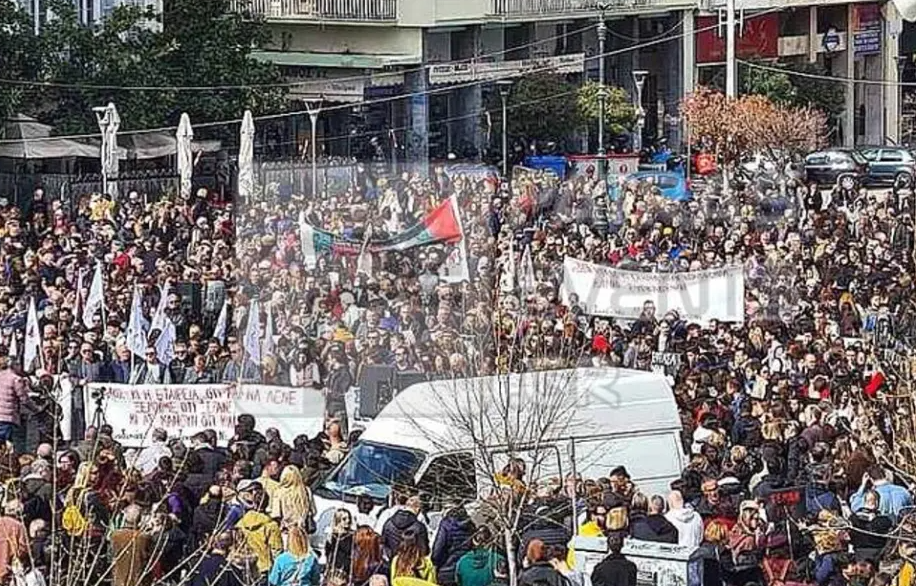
[0,24,600,92]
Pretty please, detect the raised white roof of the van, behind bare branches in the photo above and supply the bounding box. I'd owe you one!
[361,368,681,453]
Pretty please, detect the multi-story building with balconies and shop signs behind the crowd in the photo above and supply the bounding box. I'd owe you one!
[235,0,902,165]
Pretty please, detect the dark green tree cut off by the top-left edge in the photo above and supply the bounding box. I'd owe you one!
[0,0,41,120]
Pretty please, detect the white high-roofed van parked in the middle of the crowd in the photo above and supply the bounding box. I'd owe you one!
[313,368,684,541]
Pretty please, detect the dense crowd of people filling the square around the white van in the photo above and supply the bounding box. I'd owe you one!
[0,155,916,586]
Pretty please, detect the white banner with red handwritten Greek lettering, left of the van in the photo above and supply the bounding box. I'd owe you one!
[84,384,324,447]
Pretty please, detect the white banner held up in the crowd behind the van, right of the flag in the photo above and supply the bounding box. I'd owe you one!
[560,257,744,323]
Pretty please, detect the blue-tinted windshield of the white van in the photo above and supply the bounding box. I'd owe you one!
[315,441,426,500]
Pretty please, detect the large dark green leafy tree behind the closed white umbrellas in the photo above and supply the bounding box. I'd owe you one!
[17,0,286,136]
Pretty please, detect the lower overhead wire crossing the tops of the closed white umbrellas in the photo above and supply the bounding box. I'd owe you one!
[0,8,781,144]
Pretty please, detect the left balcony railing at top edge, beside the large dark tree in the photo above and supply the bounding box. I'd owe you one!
[232,0,398,22]
